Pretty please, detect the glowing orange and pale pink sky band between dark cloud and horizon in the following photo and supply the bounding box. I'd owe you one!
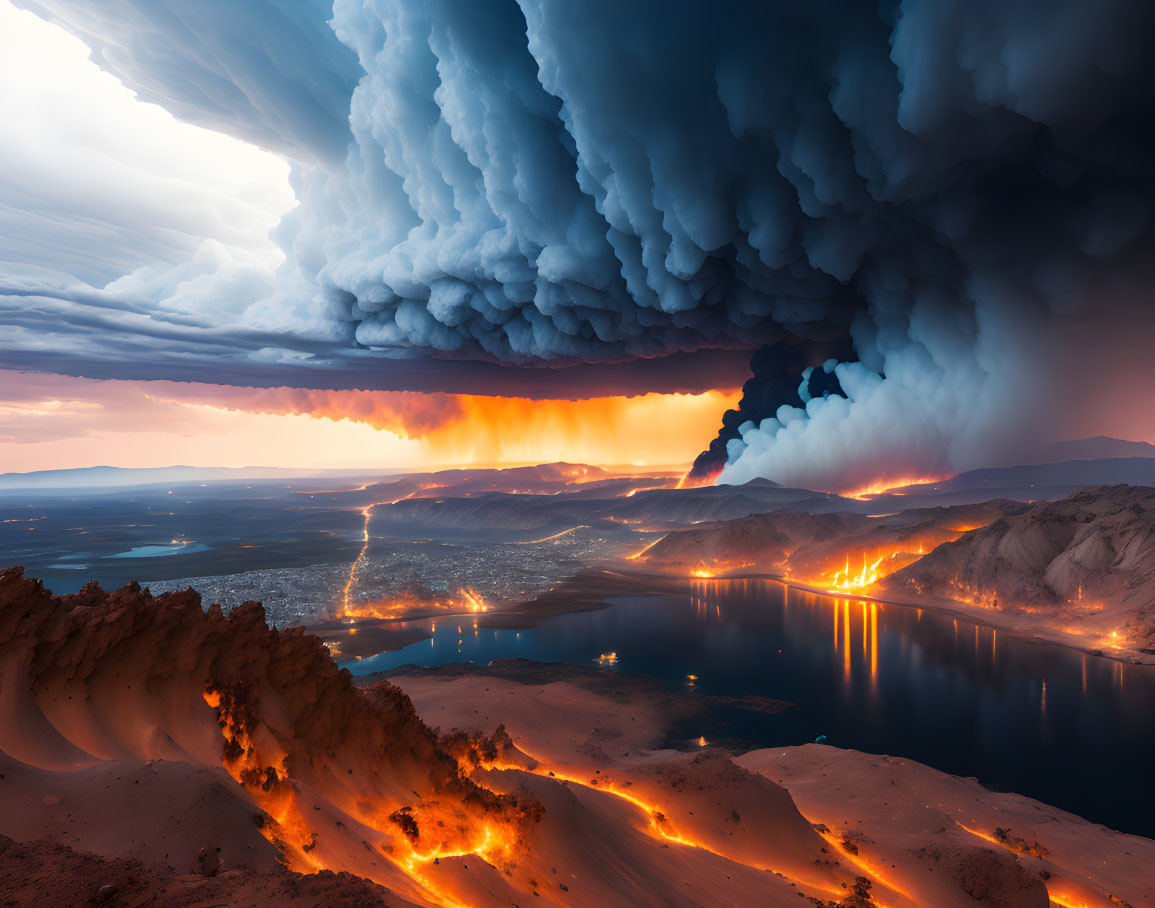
[0,371,738,472]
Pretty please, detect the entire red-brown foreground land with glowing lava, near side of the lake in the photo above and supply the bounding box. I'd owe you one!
[0,570,1155,908]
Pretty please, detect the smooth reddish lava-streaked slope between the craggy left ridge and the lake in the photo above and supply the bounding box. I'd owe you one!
[394,672,1155,908]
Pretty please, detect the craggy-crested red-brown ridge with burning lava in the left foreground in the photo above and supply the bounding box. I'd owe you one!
[0,568,541,905]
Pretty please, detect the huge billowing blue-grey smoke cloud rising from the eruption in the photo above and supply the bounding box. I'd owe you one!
[6,0,1155,489]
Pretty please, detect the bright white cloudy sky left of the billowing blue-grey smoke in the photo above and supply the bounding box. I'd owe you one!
[0,0,295,286]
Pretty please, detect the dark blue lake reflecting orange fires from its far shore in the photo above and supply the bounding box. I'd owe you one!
[350,580,1155,835]
